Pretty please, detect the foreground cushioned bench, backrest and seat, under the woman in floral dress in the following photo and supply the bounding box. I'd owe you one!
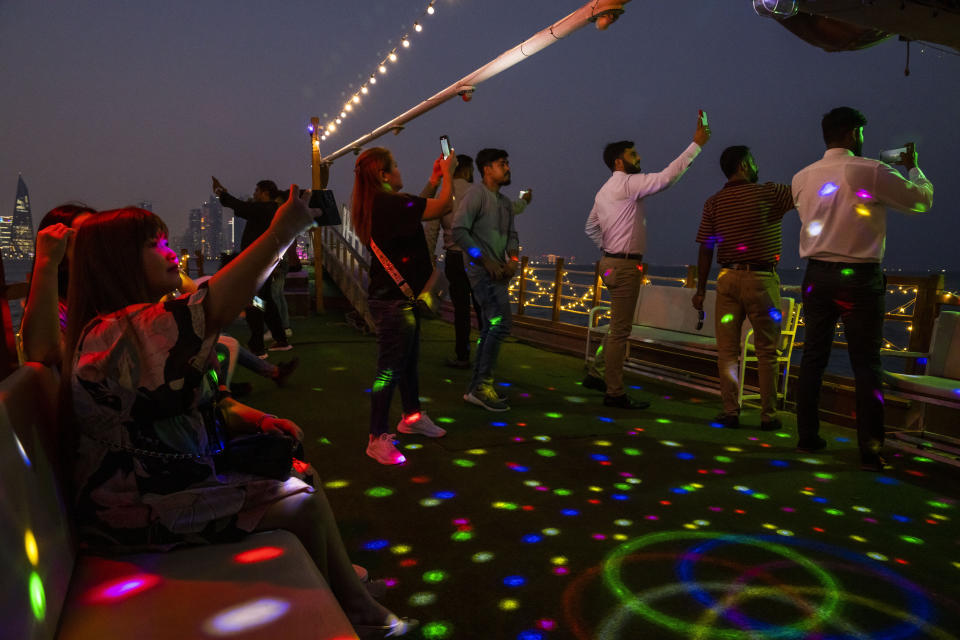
[0,363,356,640]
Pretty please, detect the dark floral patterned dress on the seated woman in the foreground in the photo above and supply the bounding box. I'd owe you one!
[76,287,313,549]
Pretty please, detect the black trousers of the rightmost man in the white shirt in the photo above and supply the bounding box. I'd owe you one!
[797,260,886,460]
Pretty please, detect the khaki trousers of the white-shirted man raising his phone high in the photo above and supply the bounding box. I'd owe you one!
[590,256,643,396]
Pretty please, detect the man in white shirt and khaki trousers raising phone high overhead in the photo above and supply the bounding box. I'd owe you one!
[583,112,710,409]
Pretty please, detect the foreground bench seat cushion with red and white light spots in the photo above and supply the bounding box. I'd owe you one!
[58,531,356,640]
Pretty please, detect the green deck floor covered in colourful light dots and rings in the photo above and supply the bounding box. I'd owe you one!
[234,312,960,640]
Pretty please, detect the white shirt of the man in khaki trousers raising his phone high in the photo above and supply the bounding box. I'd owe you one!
[584,142,700,254]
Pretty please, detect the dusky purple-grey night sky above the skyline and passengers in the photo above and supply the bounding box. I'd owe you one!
[0,0,960,269]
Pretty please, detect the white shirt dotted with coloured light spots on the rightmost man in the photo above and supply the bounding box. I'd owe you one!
[793,149,933,262]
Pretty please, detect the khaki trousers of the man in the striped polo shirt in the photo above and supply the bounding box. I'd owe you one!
[714,269,781,422]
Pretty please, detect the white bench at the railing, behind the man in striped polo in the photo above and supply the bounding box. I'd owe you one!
[584,285,800,402]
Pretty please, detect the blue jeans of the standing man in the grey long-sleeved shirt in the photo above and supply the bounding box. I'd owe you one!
[467,265,513,391]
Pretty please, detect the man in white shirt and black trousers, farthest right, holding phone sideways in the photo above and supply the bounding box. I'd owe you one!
[792,107,933,471]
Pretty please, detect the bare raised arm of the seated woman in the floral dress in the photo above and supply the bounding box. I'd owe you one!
[203,185,313,335]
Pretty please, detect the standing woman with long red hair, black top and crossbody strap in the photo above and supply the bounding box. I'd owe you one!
[350,147,457,464]
